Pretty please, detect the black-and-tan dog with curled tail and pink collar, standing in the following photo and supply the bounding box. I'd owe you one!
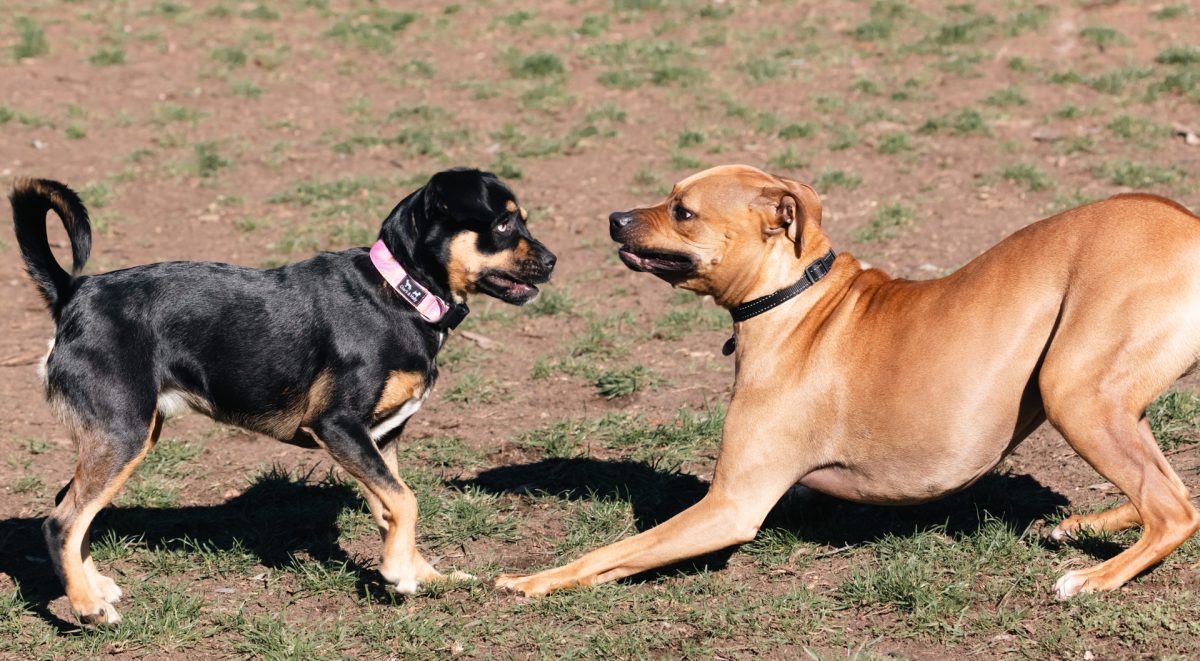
[11,169,554,624]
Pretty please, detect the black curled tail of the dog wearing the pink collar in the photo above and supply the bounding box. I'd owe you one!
[8,179,91,320]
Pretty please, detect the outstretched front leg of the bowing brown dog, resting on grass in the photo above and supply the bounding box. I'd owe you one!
[496,427,803,595]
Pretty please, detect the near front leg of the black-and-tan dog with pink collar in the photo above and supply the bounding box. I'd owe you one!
[306,417,443,594]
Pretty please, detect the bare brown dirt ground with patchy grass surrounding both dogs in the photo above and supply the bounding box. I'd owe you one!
[0,0,1200,659]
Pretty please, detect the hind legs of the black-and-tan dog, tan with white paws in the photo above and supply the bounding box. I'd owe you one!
[42,413,162,625]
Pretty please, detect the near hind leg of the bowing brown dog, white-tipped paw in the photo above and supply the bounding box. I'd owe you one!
[1048,405,1200,599]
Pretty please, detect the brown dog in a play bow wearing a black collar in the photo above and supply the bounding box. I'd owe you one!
[497,166,1200,599]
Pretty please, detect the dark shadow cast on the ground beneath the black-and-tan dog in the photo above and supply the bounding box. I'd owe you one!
[0,470,390,632]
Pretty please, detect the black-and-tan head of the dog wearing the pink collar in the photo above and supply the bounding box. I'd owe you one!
[379,168,556,305]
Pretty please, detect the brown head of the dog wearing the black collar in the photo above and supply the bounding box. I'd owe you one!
[608,166,828,306]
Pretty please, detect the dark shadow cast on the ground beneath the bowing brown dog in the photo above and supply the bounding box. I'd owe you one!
[468,458,1099,581]
